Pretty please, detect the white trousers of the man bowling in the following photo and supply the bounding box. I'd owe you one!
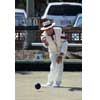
[48,53,63,84]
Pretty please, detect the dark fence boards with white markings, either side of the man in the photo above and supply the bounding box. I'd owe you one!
[15,26,82,49]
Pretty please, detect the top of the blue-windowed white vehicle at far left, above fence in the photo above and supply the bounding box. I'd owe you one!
[15,9,27,26]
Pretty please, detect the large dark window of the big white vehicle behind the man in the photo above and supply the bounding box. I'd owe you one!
[48,5,82,16]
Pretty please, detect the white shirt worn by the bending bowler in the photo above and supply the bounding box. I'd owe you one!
[41,27,68,54]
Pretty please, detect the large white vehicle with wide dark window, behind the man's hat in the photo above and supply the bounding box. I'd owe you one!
[41,2,82,27]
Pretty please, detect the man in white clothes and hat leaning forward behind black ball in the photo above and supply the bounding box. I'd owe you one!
[41,20,68,87]
